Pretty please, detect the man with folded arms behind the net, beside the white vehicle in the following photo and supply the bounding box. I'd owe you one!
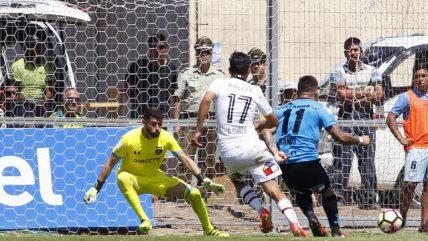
[331,37,384,209]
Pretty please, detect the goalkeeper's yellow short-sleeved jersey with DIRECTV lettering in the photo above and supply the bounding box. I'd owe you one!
[113,127,181,175]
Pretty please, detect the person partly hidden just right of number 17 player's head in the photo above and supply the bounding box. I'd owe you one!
[248,48,267,94]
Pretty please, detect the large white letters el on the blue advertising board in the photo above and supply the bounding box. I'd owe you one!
[0,148,63,207]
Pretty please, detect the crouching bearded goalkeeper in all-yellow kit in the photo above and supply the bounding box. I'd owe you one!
[84,108,229,237]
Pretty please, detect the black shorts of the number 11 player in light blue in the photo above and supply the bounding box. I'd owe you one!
[281,159,330,194]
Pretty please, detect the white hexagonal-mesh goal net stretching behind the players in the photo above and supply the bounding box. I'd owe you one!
[0,0,428,233]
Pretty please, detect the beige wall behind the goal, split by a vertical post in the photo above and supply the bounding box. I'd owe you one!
[189,0,427,84]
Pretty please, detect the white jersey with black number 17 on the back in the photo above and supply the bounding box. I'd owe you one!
[207,78,273,152]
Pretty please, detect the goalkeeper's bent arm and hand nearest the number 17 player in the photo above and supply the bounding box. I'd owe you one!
[176,151,224,194]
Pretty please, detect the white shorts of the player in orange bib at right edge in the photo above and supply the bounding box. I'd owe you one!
[404,148,428,182]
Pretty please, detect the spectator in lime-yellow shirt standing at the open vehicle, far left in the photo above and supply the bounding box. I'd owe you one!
[11,35,55,116]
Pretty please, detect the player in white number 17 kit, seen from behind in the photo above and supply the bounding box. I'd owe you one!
[192,51,306,236]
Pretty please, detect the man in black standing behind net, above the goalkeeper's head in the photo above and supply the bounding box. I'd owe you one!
[125,33,178,118]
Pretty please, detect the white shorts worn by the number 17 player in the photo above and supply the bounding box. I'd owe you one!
[220,142,282,184]
